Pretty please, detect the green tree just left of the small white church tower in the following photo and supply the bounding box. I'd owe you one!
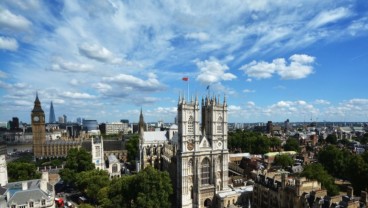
[59,148,95,185]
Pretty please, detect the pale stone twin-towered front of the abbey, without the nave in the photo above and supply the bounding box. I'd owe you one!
[177,97,229,207]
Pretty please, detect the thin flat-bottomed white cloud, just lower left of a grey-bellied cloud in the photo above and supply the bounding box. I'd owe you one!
[48,57,93,72]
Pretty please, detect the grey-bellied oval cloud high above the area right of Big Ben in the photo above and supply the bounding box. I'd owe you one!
[79,43,123,64]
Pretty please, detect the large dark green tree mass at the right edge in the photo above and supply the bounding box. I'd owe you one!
[318,145,368,192]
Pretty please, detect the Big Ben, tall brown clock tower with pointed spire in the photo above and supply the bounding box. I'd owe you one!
[31,94,46,158]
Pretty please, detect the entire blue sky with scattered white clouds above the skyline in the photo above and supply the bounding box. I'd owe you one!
[0,0,368,122]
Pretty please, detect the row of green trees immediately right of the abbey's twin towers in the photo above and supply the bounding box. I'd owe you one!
[228,130,300,154]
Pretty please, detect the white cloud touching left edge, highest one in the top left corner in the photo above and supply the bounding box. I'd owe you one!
[0,7,32,31]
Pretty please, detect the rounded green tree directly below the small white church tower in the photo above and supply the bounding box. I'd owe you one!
[76,169,110,203]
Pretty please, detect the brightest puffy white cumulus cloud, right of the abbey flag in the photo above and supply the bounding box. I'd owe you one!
[240,54,315,79]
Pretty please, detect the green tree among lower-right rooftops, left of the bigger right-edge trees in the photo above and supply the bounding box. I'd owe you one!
[301,163,339,196]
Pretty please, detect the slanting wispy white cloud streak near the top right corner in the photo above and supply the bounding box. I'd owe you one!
[308,7,351,28]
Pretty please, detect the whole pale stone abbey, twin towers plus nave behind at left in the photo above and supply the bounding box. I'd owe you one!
[140,96,231,208]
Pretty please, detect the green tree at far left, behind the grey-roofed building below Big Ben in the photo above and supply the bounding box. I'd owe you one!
[7,162,41,182]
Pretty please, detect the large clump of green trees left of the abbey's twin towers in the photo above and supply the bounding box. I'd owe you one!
[60,149,173,208]
